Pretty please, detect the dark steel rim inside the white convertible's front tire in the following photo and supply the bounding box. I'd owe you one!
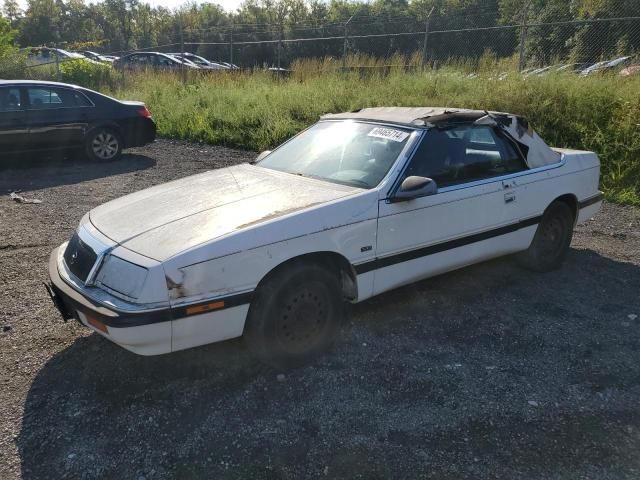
[276,288,329,352]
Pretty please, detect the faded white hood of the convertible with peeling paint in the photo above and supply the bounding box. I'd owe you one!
[89,164,362,261]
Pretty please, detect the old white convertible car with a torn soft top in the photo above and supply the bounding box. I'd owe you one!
[49,108,602,361]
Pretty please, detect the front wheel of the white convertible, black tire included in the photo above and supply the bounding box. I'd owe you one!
[244,263,345,368]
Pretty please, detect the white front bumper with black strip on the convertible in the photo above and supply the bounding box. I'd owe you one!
[47,248,172,355]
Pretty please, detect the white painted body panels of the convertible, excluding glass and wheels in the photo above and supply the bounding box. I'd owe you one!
[50,109,601,355]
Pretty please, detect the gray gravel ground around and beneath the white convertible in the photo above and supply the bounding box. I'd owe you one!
[0,141,640,480]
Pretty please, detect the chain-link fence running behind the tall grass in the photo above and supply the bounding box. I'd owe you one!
[6,12,640,79]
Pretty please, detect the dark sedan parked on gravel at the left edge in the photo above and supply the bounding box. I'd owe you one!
[0,80,156,161]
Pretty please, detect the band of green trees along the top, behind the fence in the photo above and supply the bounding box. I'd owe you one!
[2,0,640,65]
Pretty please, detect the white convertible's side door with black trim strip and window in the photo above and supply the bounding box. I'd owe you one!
[374,125,530,294]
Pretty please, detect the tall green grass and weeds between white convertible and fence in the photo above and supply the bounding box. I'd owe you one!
[112,57,640,205]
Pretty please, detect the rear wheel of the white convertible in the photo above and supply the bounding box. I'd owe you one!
[516,202,575,272]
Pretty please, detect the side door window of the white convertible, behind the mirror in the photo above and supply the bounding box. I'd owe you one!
[405,125,527,187]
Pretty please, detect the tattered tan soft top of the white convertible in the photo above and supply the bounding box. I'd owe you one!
[322,107,561,168]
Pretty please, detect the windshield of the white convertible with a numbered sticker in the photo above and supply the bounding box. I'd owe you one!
[258,121,411,188]
